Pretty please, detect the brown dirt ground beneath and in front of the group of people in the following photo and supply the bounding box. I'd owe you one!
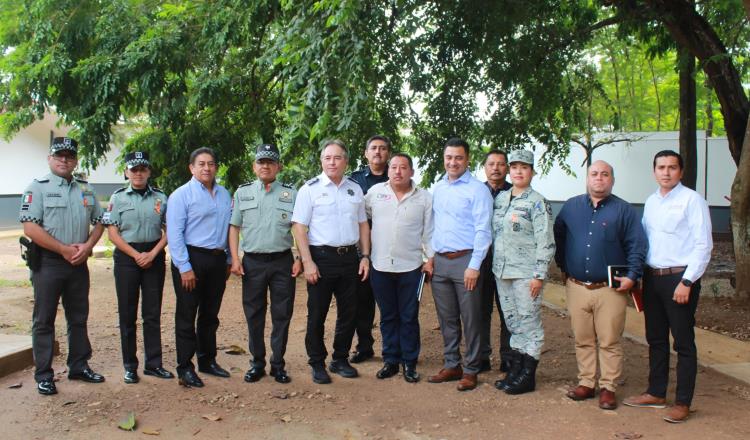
[0,239,750,440]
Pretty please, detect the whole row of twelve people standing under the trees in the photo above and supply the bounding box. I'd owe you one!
[20,136,712,421]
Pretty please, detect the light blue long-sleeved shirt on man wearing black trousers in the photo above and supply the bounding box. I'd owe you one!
[167,177,232,273]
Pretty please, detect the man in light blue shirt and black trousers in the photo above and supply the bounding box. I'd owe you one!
[167,148,232,387]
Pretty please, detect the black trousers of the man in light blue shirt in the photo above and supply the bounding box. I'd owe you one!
[172,246,227,375]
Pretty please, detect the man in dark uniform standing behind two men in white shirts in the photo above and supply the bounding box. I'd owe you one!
[349,135,391,364]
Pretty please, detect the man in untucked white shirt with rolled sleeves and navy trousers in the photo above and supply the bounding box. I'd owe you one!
[365,153,434,383]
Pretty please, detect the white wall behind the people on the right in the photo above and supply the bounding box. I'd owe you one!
[477,131,737,206]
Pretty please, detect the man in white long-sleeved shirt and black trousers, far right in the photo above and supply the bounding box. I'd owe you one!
[623,150,713,423]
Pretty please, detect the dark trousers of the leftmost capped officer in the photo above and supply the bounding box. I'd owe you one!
[31,251,91,382]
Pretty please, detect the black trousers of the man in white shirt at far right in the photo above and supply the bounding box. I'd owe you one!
[643,268,701,406]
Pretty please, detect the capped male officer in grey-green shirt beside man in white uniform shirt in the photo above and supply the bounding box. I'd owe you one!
[229,144,302,383]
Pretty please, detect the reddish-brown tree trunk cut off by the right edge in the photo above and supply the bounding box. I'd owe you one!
[731,113,750,298]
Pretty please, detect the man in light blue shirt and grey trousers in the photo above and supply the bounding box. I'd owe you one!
[428,138,492,391]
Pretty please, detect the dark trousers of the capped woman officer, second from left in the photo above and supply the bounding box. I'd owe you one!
[114,241,166,370]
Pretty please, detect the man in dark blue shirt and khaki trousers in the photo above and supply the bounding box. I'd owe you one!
[555,161,647,410]
